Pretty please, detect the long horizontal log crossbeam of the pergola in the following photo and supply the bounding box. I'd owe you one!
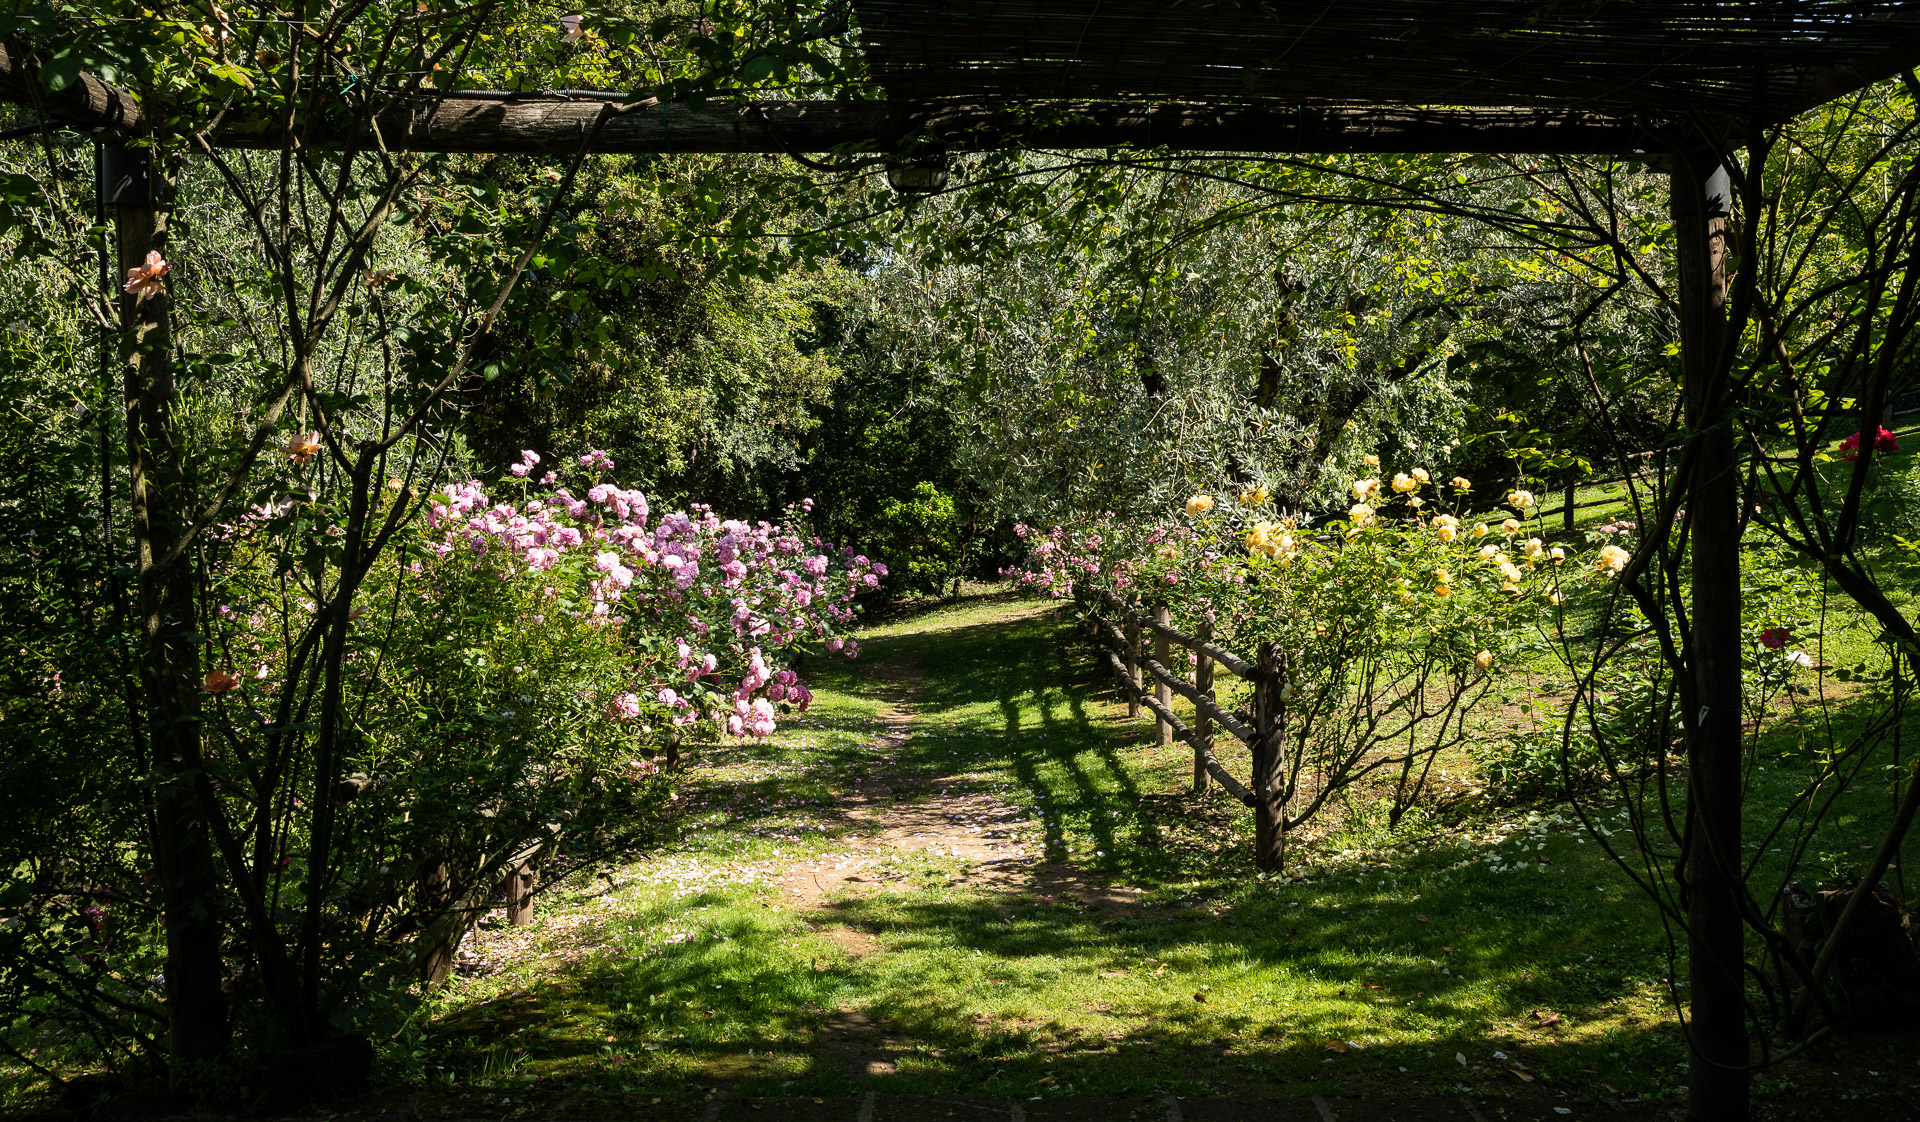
[0,44,1647,156]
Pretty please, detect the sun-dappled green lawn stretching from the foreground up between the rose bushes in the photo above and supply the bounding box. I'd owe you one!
[422,598,1910,1097]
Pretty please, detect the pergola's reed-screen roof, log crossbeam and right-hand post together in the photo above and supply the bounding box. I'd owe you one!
[0,0,1920,1118]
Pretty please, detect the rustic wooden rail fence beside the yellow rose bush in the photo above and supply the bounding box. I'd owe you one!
[1087,592,1288,870]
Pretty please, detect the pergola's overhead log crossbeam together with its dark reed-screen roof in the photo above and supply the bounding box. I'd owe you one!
[11,0,1920,156]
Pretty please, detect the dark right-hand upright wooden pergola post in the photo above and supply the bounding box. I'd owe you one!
[1668,152,1749,1122]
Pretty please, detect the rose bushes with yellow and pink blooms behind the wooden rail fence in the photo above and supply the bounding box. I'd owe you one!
[1018,469,1599,824]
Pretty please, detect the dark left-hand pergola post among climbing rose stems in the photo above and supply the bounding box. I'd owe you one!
[104,148,228,1095]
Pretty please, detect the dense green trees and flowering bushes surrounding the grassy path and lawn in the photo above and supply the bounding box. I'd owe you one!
[0,0,1920,1097]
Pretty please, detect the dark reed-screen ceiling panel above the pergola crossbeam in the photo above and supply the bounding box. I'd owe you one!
[854,0,1920,119]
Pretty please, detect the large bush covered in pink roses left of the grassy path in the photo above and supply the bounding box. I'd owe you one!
[187,450,887,983]
